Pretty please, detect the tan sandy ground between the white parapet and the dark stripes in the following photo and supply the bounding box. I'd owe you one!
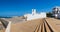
[11,19,43,32]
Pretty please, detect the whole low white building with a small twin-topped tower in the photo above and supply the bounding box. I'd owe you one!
[24,9,46,20]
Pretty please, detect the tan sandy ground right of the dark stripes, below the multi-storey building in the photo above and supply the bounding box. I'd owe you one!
[46,18,60,32]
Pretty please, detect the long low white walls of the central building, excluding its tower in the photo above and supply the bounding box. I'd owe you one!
[25,12,46,20]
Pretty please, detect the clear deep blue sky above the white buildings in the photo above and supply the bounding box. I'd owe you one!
[0,0,60,16]
